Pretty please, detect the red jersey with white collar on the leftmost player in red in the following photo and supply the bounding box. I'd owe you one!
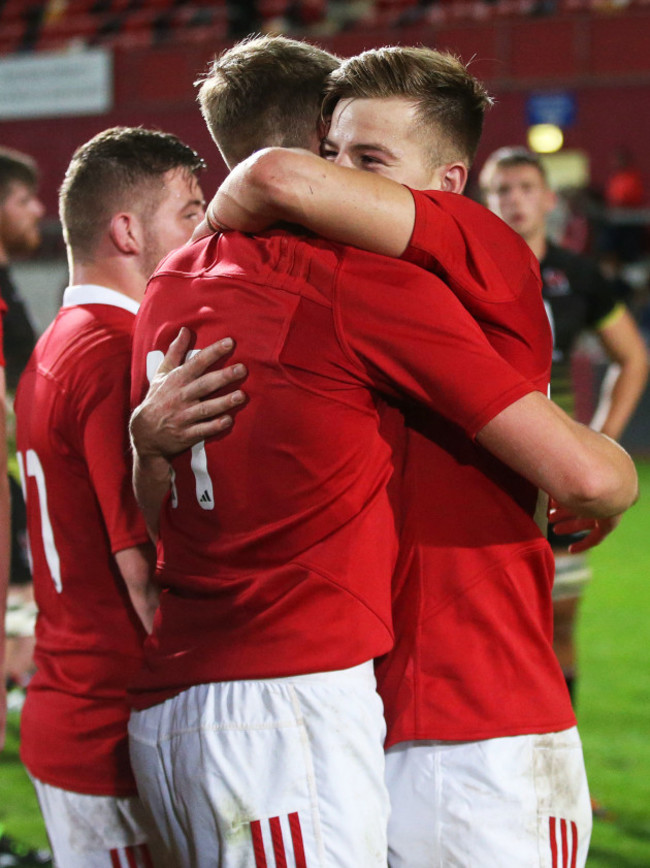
[16,286,147,795]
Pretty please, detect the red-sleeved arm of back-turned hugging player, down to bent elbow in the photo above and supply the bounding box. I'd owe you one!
[336,249,638,518]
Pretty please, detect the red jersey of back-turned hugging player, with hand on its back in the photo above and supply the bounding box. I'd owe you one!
[133,231,532,708]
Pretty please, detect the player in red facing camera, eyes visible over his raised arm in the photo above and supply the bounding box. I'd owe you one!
[197,49,636,865]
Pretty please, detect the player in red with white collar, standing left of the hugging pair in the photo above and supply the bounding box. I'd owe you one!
[15,127,243,868]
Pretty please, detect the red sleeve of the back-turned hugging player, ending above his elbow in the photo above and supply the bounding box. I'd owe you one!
[334,249,535,437]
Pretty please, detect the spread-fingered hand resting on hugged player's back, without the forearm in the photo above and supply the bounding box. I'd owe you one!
[130,328,247,458]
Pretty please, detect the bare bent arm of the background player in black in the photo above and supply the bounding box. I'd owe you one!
[591,309,648,440]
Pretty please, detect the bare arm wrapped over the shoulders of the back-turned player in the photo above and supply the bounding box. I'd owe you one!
[201,148,415,256]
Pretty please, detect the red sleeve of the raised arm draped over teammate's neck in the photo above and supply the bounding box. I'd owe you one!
[402,190,541,304]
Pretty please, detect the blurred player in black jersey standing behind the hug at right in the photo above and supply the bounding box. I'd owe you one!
[479,148,648,744]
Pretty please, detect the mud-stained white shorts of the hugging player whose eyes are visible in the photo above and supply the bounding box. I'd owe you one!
[386,727,592,868]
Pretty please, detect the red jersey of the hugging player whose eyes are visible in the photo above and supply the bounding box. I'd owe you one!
[376,192,575,746]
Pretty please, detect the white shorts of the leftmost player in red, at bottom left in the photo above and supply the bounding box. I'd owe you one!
[32,777,168,868]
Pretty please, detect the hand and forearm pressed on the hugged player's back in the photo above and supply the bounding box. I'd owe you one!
[129,328,246,539]
